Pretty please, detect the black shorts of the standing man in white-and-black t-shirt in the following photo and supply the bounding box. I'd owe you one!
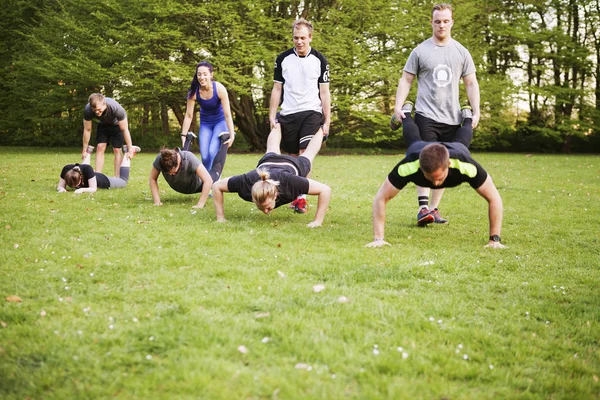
[277,111,323,154]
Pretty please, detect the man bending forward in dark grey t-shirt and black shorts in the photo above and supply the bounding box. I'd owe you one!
[81,93,135,176]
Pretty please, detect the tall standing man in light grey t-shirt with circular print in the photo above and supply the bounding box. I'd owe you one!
[394,4,480,225]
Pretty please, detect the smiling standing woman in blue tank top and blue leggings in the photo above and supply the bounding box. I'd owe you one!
[181,61,235,171]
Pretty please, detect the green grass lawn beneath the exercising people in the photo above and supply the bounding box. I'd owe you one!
[0,148,600,399]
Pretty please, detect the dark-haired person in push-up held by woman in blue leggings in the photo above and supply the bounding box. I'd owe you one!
[148,134,229,208]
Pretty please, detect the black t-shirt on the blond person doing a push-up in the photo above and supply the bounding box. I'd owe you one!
[227,153,310,208]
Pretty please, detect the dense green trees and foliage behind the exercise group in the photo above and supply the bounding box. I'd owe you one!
[0,0,600,152]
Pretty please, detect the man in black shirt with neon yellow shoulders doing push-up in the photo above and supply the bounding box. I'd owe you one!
[366,108,506,248]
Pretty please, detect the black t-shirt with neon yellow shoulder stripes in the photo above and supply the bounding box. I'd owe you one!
[388,141,488,190]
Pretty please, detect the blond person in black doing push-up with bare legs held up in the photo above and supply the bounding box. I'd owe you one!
[212,127,331,228]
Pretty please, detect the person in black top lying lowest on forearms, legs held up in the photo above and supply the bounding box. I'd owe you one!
[56,146,142,194]
